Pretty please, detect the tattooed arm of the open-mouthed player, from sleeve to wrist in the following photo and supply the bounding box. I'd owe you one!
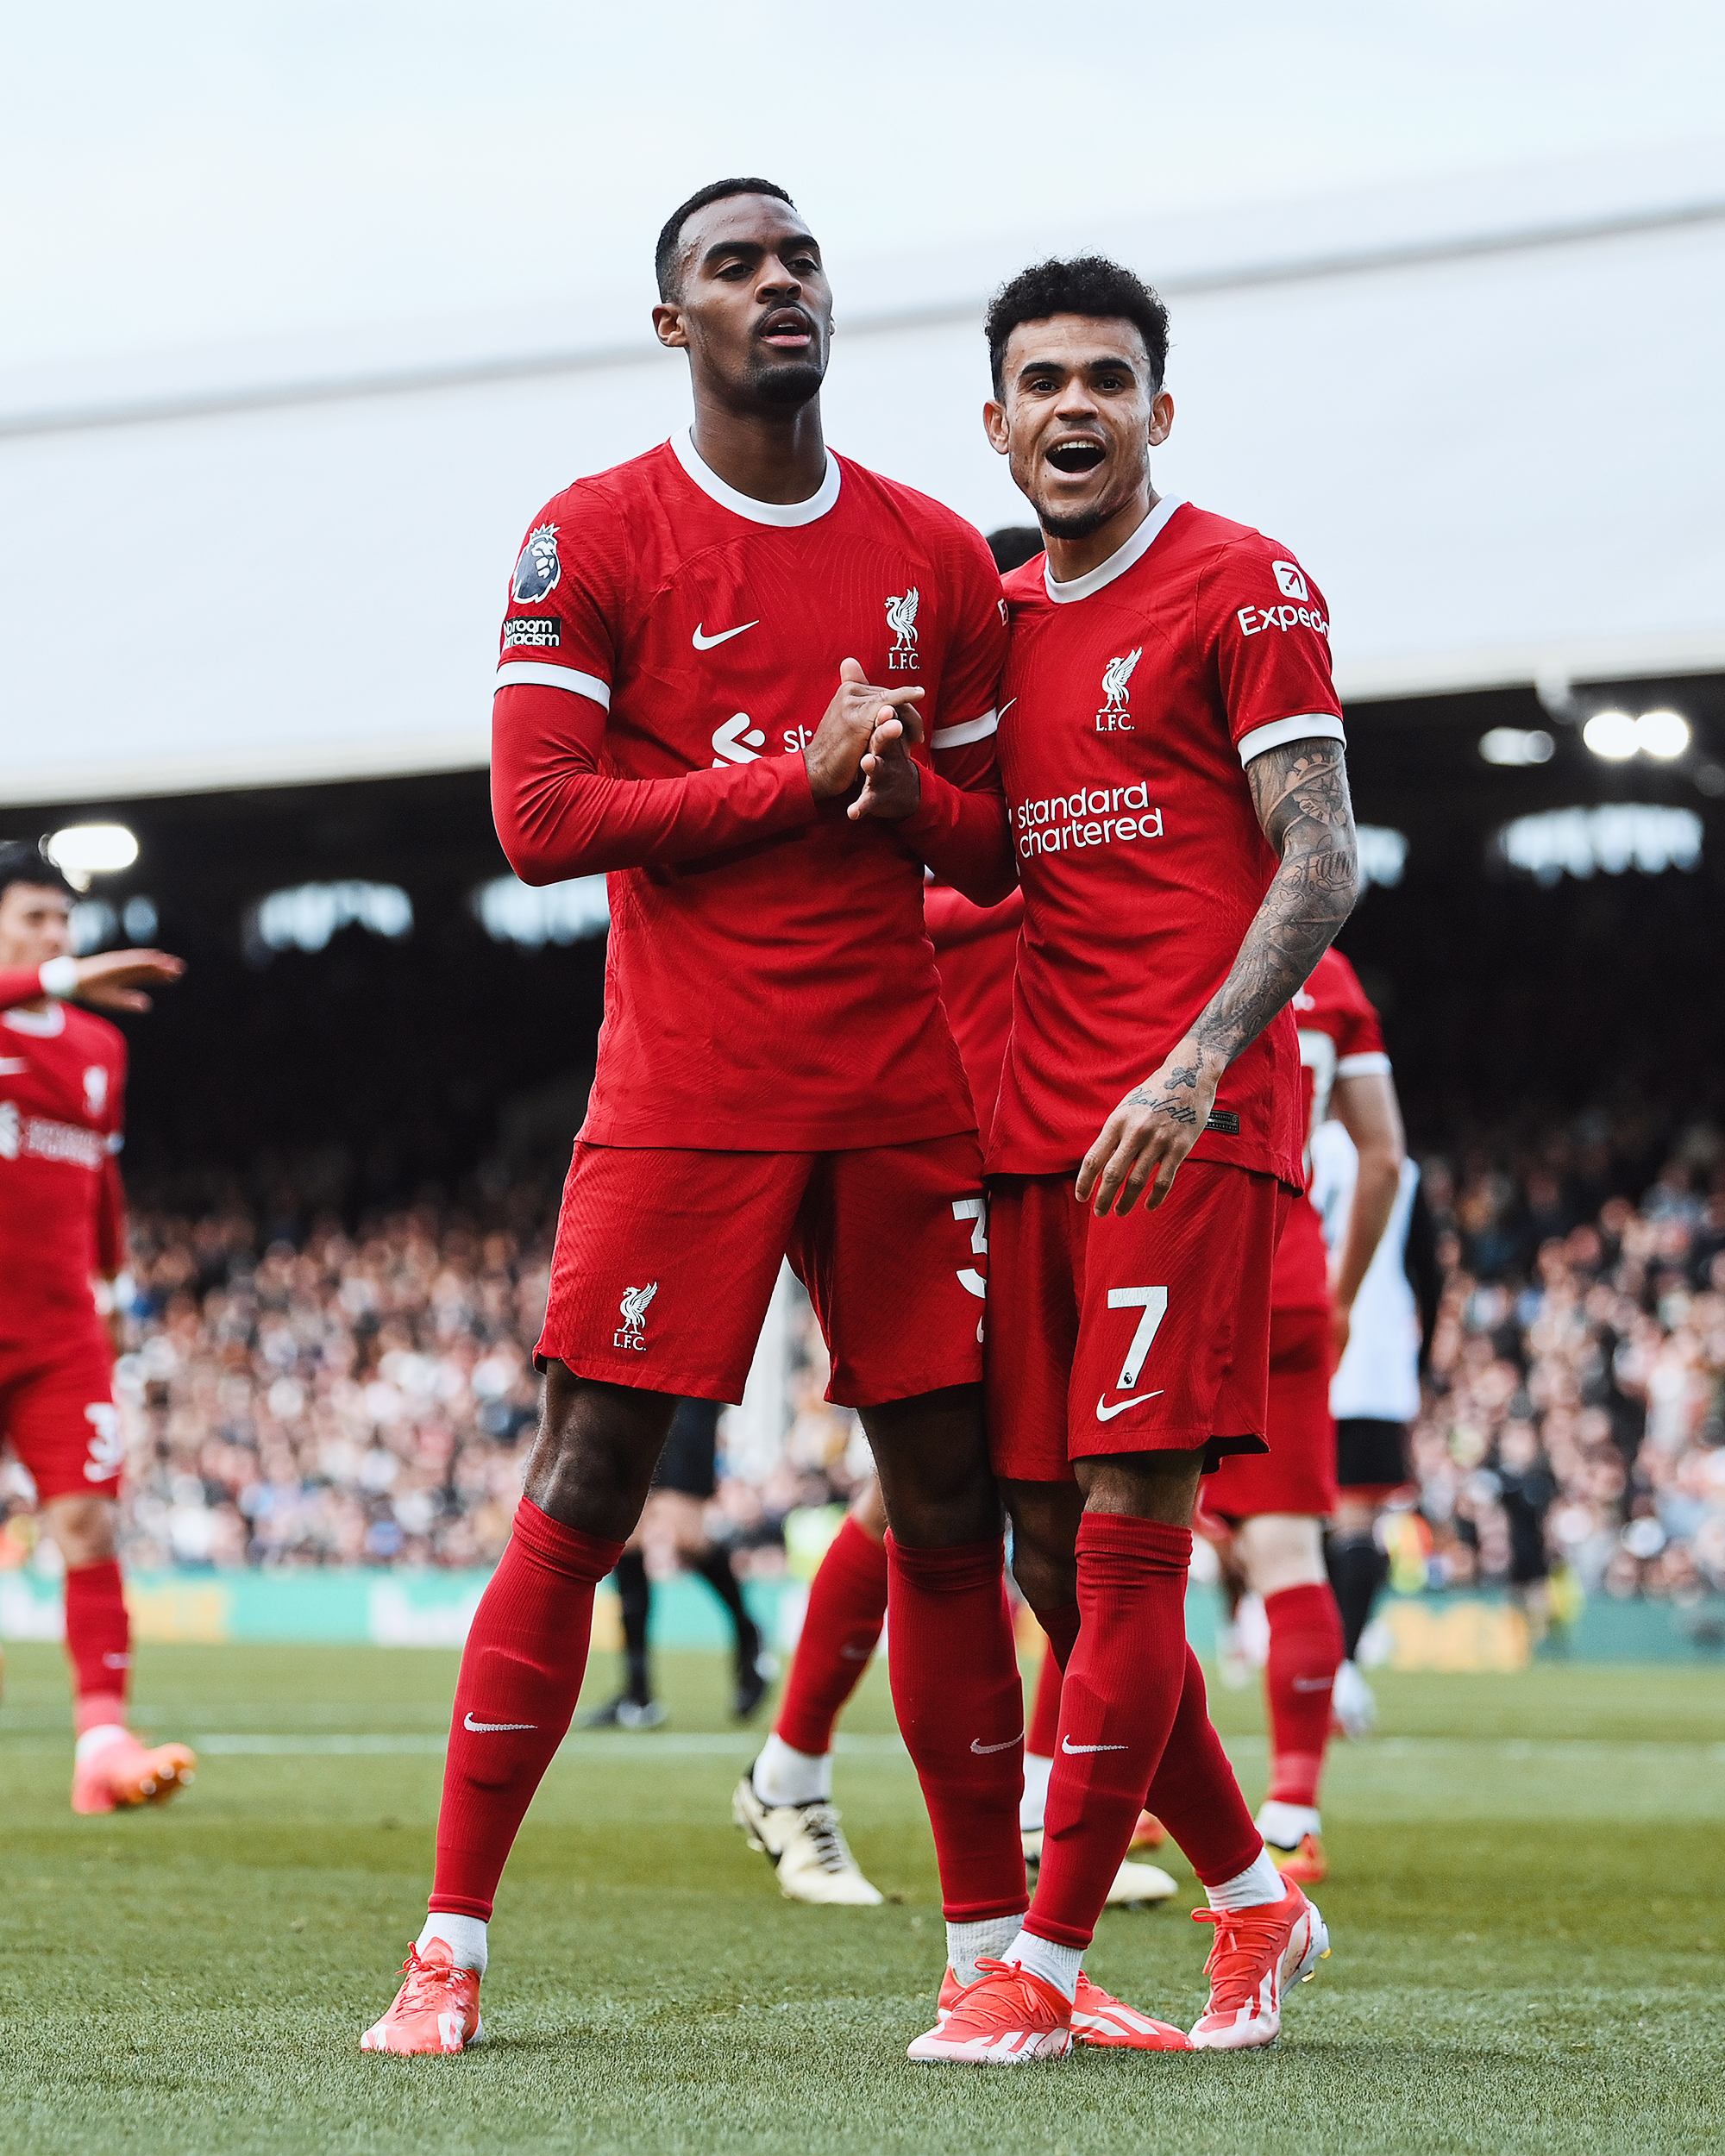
[1193,742,1358,1063]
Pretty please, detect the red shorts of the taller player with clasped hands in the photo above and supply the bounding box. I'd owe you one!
[535,1130,988,1408]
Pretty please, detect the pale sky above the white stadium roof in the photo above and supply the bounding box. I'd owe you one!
[0,0,1725,367]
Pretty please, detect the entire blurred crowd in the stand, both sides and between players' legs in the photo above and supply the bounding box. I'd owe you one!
[0,1132,1725,1615]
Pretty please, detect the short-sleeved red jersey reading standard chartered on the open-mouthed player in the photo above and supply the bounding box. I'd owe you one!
[988,500,1341,1184]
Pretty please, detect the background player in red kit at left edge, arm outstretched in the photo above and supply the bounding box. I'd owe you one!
[0,841,197,1811]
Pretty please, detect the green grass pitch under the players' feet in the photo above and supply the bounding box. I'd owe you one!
[0,1647,1725,2156]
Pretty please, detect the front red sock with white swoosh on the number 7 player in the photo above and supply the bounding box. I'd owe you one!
[1025,1512,1193,1947]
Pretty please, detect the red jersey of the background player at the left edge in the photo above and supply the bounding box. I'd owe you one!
[0,968,125,1345]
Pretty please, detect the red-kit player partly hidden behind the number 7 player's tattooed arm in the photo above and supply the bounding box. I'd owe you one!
[1203,951,1402,1887]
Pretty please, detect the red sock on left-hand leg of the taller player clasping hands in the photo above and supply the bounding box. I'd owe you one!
[430,1499,624,1917]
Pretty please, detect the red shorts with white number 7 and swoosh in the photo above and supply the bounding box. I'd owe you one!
[988,1160,1288,1482]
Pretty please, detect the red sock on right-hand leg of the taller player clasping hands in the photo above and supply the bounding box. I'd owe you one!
[887,1535,1029,1923]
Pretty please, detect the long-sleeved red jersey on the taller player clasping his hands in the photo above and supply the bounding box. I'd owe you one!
[492,438,1005,1151]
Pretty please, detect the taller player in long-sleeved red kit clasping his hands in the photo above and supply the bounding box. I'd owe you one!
[362,179,1026,2051]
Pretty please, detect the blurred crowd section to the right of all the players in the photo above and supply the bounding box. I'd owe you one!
[1393,1125,1725,1617]
